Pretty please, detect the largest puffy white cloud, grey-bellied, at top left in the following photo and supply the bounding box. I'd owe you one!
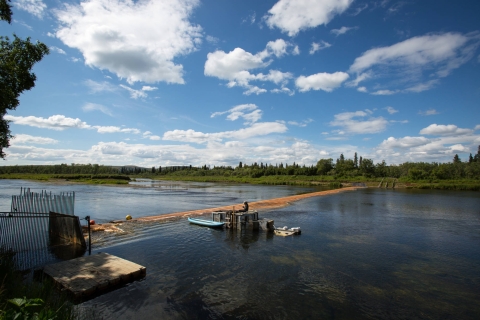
[54,0,202,84]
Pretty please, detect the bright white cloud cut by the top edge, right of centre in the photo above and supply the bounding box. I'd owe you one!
[264,0,353,36]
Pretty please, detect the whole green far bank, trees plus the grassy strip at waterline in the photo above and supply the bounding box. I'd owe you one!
[0,146,480,190]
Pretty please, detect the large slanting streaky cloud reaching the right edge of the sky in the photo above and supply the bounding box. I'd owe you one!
[349,32,480,94]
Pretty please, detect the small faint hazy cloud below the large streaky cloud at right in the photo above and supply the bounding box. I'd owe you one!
[330,111,388,134]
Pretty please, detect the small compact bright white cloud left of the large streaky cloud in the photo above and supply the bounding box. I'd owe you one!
[295,72,349,92]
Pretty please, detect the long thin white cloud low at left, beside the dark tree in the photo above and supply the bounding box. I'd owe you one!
[4,114,140,134]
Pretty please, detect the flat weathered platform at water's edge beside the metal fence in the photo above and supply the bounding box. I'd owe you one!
[43,253,147,300]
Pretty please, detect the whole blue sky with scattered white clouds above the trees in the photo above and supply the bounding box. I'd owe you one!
[0,0,480,167]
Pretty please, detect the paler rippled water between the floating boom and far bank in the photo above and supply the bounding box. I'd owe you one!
[0,180,321,223]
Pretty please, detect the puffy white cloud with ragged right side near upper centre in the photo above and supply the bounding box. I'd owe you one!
[204,39,293,95]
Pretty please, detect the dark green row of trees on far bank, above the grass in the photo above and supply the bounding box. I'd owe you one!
[0,146,480,181]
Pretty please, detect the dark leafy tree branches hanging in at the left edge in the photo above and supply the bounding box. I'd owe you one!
[0,0,49,159]
